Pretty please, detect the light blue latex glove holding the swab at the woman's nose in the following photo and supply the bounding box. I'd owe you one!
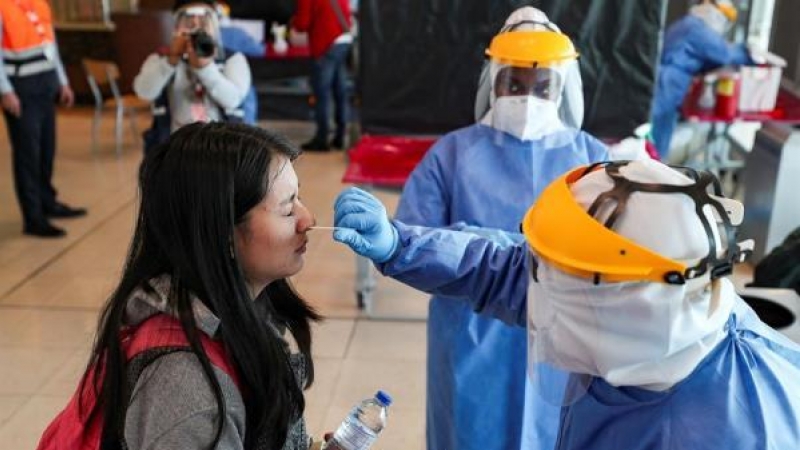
[333,187,399,263]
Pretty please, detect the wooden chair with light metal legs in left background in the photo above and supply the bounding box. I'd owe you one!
[82,58,150,155]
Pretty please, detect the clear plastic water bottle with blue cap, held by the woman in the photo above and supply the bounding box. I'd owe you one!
[322,391,392,450]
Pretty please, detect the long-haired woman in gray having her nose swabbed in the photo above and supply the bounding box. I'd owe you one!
[50,123,319,450]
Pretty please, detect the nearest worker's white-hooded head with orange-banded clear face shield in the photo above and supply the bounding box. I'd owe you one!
[524,161,752,406]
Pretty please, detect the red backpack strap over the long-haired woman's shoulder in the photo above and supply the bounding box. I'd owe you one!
[123,314,241,390]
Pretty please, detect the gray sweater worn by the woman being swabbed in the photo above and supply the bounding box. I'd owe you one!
[125,277,310,450]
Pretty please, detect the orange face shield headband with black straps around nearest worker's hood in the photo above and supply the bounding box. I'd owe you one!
[522,161,753,284]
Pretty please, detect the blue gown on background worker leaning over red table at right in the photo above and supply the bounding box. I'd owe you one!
[651,15,753,160]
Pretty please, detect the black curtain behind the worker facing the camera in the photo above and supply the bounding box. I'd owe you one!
[358,0,666,138]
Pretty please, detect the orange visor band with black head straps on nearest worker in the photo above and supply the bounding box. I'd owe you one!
[522,163,749,284]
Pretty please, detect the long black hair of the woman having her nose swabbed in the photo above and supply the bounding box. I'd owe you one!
[81,123,320,448]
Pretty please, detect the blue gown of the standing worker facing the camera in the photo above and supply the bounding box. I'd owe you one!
[395,124,607,450]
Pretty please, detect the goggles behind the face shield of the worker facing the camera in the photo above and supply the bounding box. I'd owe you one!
[494,66,564,100]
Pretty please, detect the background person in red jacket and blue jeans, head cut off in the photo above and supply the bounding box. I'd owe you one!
[291,0,353,151]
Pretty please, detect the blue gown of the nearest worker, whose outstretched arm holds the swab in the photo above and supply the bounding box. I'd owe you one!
[377,227,800,450]
